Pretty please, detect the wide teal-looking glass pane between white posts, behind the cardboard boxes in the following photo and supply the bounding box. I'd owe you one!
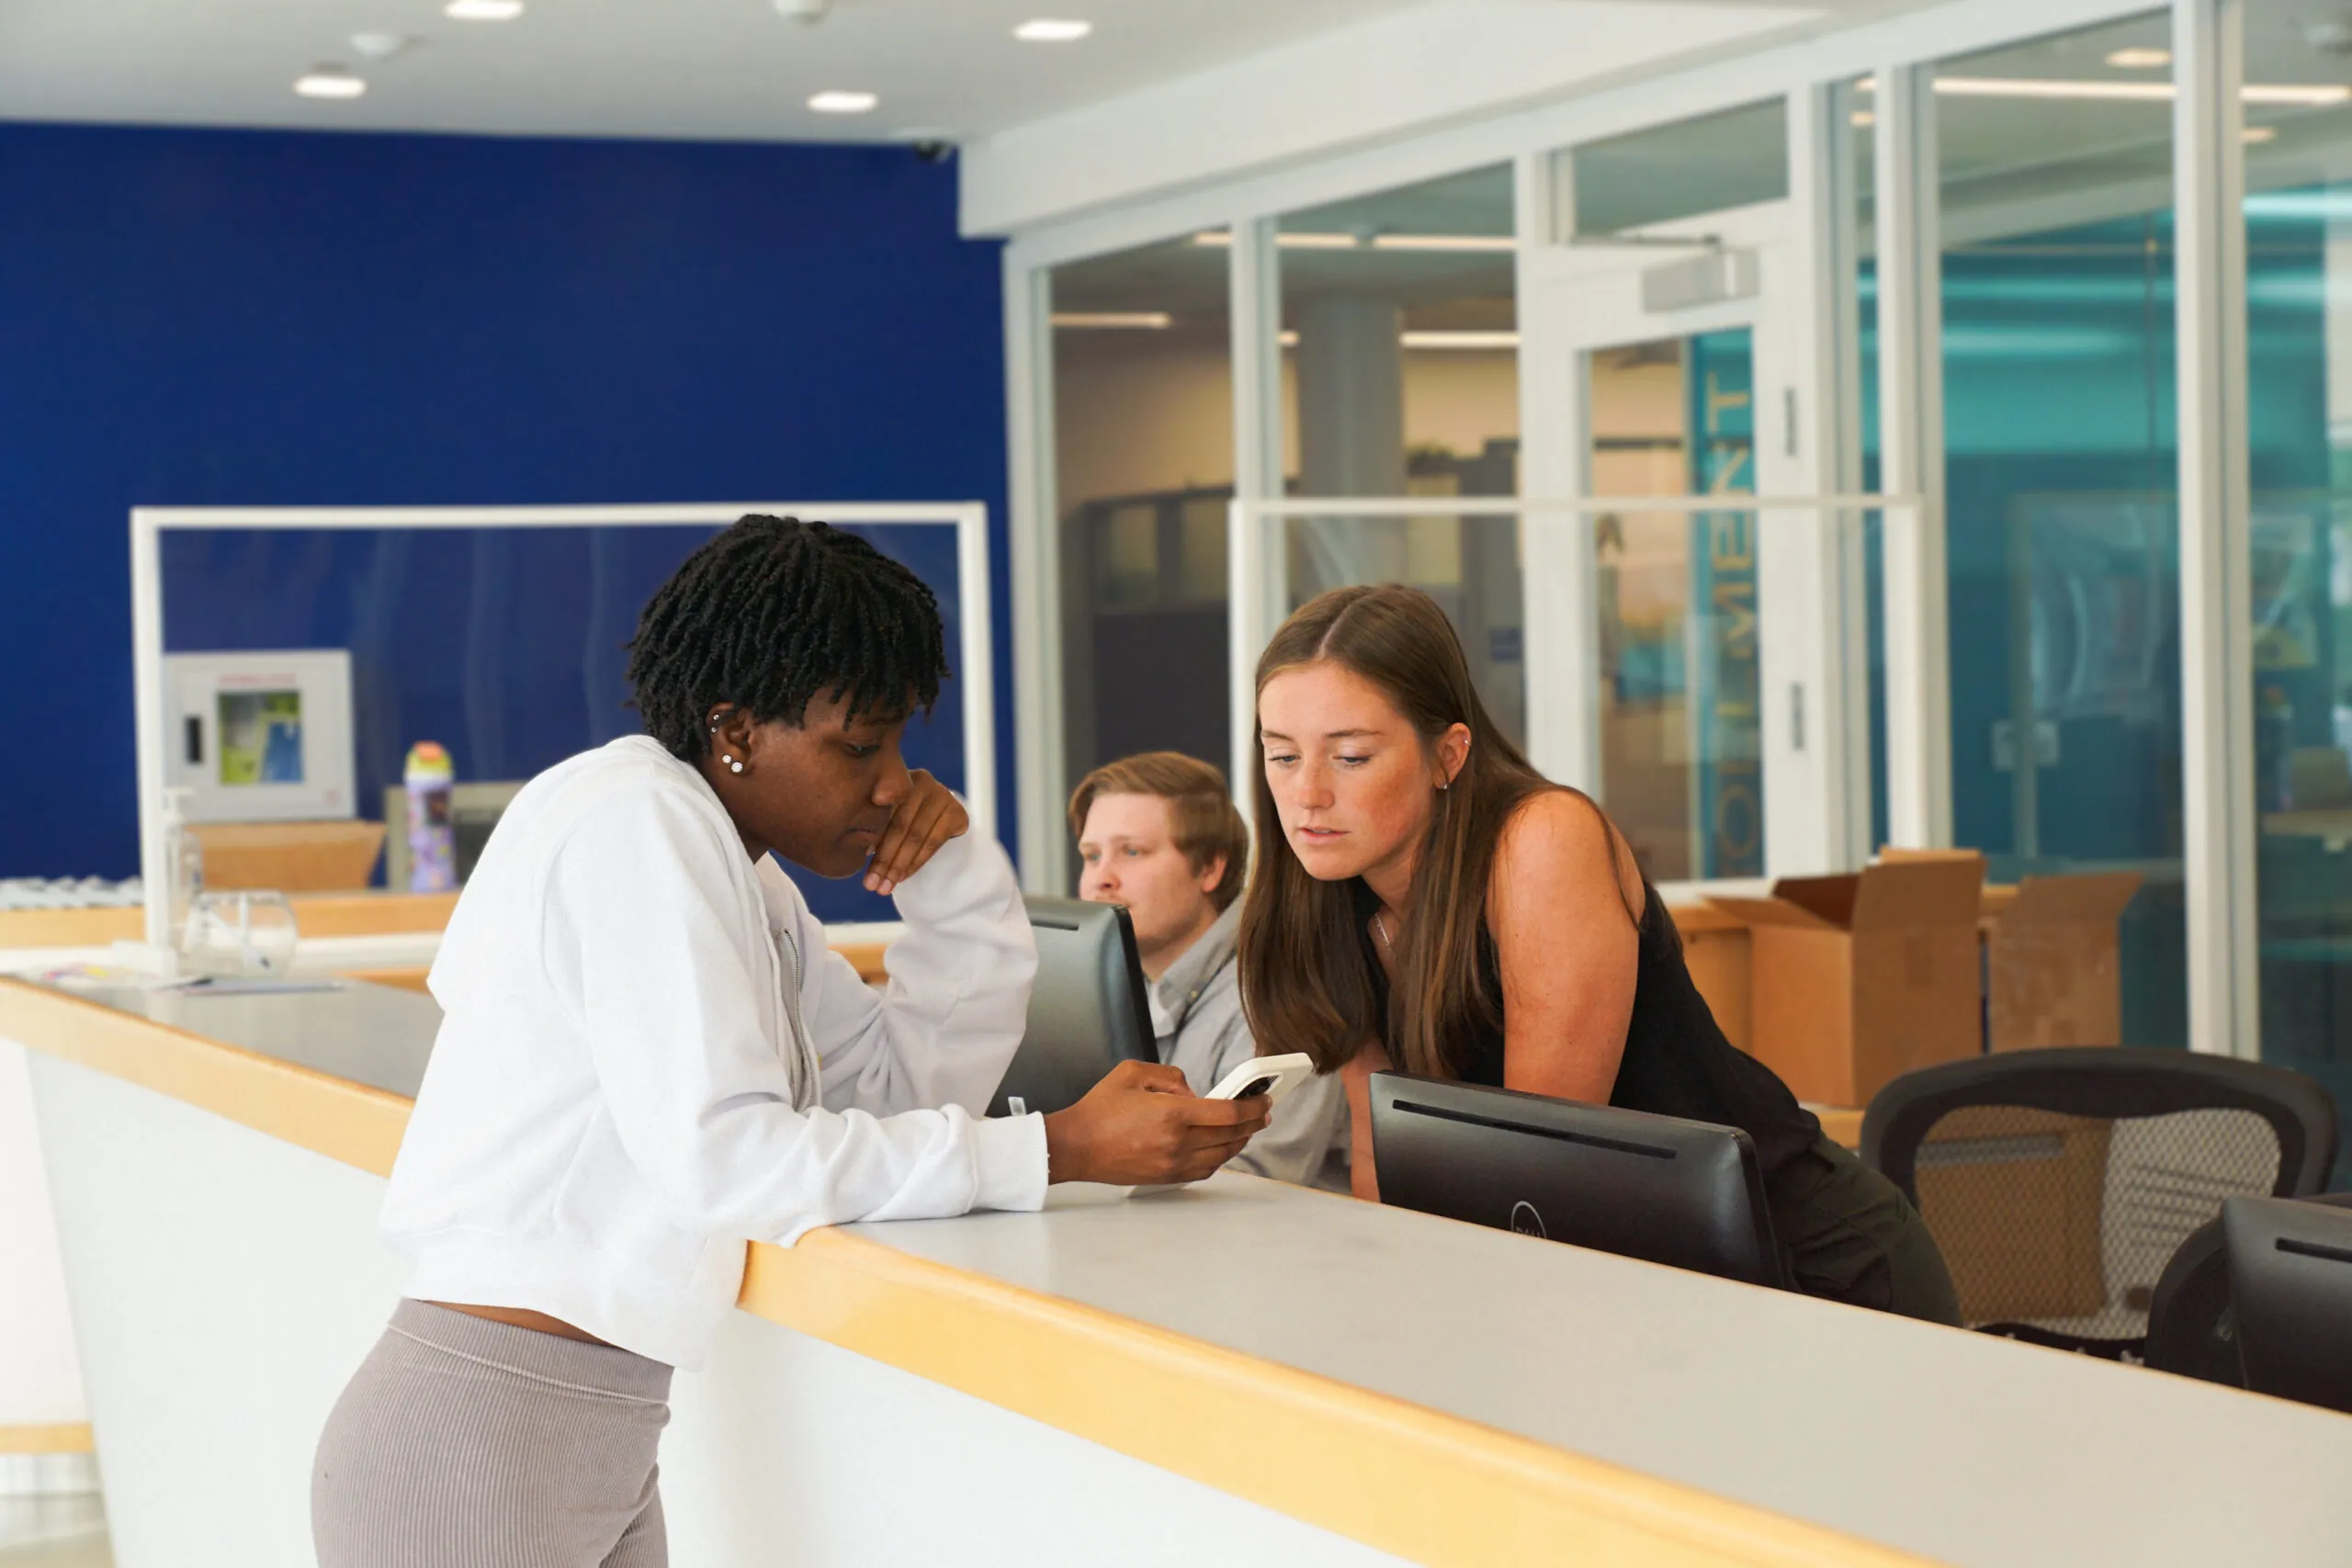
[1936,12,2188,1043]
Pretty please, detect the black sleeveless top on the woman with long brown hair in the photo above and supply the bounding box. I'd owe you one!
[1355,877,1820,1180]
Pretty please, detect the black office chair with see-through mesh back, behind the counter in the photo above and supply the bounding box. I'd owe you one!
[1863,1046,2335,1359]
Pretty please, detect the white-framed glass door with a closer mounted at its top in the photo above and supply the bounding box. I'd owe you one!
[1526,177,1870,882]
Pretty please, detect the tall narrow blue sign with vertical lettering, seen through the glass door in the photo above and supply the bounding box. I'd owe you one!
[1684,327,1764,877]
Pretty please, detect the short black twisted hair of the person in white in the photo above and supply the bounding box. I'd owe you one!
[628,514,948,761]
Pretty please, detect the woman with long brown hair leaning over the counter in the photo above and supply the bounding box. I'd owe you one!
[1242,585,1959,1324]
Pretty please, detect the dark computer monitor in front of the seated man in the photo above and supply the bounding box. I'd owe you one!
[988,898,1159,1117]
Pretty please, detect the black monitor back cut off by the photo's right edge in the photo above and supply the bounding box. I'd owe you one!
[2221,1194,2352,1413]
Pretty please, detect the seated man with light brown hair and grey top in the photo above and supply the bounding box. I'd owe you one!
[1070,752,1348,1192]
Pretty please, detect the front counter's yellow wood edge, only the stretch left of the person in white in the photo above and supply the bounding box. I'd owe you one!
[0,980,412,1176]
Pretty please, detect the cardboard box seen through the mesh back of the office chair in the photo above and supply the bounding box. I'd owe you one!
[1915,1105,2112,1324]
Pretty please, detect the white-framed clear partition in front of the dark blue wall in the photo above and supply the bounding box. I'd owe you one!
[131,503,997,941]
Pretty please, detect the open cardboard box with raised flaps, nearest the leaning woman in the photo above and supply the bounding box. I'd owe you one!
[1710,856,1985,1105]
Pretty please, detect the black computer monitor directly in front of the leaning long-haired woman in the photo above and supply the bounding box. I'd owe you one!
[1371,1072,1785,1286]
